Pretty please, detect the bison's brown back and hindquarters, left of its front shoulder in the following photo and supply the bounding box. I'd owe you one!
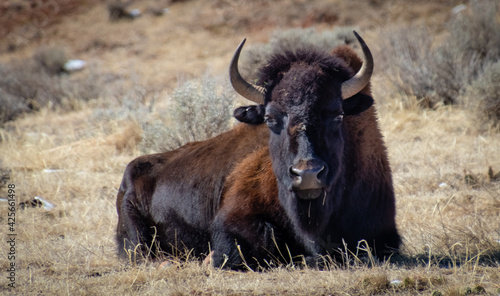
[116,124,269,256]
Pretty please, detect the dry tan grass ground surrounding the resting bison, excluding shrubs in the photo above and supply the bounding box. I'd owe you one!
[0,0,500,295]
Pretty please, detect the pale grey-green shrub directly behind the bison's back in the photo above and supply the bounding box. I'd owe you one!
[140,76,236,154]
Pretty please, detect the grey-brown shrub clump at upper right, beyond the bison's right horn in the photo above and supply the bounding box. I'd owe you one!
[381,0,500,113]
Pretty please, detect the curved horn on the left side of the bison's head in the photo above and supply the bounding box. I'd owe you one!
[229,39,266,104]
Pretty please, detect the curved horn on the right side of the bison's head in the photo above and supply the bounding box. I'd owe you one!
[341,31,373,99]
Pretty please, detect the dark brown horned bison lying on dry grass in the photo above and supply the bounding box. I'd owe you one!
[117,32,400,269]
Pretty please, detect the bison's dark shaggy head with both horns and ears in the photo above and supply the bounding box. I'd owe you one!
[230,32,373,236]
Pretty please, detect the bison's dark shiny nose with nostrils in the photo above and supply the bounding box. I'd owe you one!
[289,160,328,190]
